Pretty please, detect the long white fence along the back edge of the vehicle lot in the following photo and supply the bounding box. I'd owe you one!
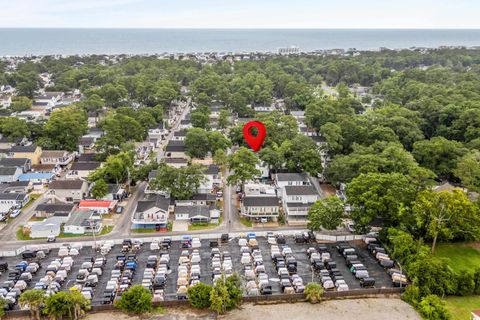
[0,230,365,257]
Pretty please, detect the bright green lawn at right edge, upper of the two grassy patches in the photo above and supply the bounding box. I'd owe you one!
[435,242,480,272]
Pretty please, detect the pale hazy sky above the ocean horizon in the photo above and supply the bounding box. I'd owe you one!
[0,0,480,28]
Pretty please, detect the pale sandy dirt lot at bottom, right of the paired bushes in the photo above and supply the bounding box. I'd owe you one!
[219,298,421,320]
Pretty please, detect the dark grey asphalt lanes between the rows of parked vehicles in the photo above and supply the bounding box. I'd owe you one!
[0,237,392,304]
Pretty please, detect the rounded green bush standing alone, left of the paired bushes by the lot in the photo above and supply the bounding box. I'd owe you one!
[115,285,152,314]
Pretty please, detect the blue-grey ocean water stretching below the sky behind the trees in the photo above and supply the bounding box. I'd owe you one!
[0,29,480,56]
